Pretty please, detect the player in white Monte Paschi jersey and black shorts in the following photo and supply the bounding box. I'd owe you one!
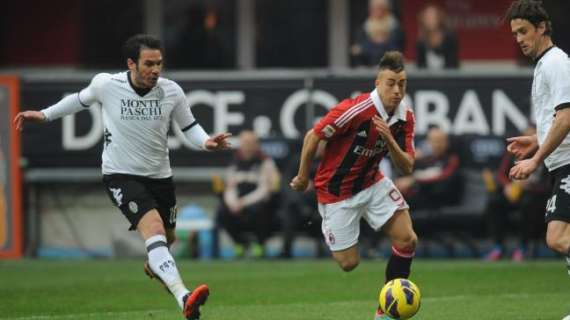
[14,35,230,319]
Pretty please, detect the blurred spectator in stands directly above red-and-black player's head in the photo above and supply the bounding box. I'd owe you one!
[350,0,404,66]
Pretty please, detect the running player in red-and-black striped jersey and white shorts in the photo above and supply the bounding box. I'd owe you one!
[290,51,417,319]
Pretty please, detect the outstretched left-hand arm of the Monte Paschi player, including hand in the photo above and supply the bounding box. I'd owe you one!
[14,73,105,130]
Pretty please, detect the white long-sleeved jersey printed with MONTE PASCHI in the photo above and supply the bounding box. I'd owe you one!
[42,72,207,178]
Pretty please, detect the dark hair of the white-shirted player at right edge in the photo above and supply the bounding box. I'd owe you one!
[505,0,552,36]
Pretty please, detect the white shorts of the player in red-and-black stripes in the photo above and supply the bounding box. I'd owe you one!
[319,177,409,251]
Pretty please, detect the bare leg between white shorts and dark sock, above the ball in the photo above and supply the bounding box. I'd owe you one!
[384,209,417,249]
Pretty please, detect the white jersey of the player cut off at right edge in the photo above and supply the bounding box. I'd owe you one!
[532,47,570,171]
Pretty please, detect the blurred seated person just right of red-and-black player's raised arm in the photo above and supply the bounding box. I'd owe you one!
[395,127,463,209]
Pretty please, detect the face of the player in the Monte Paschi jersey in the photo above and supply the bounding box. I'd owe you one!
[128,49,162,88]
